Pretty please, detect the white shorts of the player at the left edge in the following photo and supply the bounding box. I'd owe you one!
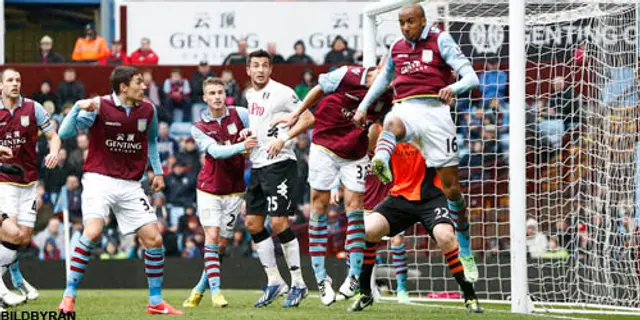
[0,182,37,228]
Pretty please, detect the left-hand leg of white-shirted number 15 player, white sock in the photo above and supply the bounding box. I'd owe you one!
[245,215,288,308]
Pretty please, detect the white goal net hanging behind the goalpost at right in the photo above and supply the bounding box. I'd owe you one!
[364,0,640,314]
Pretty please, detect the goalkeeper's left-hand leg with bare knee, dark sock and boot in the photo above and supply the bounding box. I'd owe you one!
[347,212,390,312]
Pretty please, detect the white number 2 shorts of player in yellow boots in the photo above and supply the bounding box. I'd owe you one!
[197,190,243,239]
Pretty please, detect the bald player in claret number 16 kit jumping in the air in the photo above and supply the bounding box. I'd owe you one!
[354,4,478,282]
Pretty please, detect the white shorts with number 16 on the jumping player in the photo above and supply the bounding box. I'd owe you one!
[387,99,462,168]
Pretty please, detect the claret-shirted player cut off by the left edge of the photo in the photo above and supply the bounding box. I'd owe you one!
[0,69,61,306]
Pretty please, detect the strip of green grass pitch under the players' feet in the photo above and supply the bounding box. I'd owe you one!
[11,289,636,320]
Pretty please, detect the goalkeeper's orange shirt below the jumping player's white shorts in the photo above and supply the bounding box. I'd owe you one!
[389,142,442,201]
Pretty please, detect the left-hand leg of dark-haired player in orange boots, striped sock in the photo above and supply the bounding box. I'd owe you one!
[58,218,104,313]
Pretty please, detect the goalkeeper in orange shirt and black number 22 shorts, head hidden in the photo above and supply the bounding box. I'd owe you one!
[348,122,483,313]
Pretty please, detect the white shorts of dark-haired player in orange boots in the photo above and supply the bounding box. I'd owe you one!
[82,172,158,235]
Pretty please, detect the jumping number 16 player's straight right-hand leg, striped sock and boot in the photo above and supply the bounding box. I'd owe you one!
[438,166,478,282]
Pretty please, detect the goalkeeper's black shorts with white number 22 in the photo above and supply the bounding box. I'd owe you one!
[373,194,453,238]
